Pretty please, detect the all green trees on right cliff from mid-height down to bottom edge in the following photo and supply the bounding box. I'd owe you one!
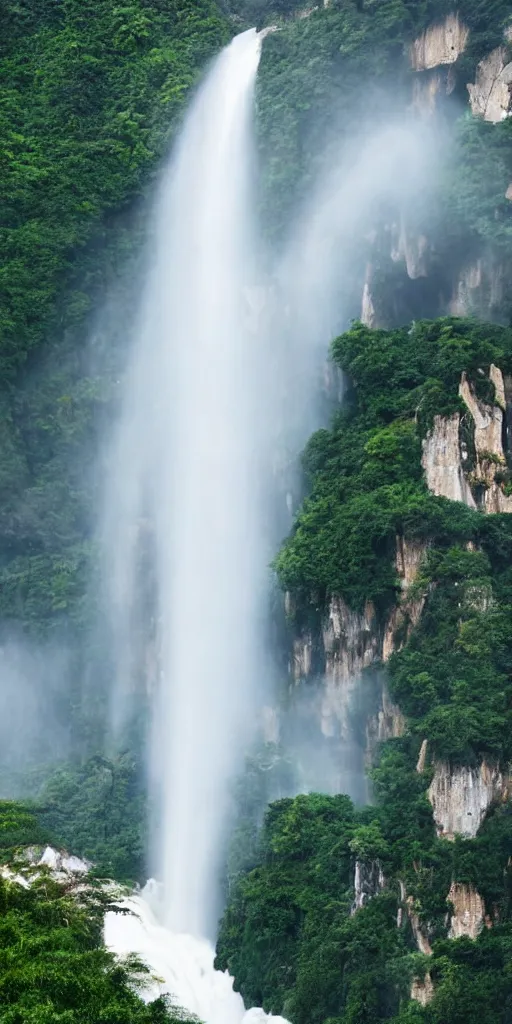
[218,318,512,1024]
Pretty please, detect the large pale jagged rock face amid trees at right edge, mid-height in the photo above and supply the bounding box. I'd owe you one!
[422,366,512,513]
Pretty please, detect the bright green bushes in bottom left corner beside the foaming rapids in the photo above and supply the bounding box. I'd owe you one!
[0,803,191,1024]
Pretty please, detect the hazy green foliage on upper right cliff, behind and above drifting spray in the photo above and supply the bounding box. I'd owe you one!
[258,0,512,245]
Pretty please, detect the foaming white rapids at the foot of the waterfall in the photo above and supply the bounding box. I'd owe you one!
[104,883,287,1024]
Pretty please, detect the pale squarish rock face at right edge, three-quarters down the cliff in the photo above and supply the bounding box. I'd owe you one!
[428,761,511,840]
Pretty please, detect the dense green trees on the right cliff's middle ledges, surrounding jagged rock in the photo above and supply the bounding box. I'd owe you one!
[275,319,512,763]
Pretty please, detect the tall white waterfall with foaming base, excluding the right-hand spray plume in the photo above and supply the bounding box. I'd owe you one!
[103,30,288,1024]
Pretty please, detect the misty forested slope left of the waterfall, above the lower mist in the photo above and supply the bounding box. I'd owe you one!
[0,0,233,770]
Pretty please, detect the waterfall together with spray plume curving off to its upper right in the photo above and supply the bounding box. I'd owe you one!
[103,22,440,1024]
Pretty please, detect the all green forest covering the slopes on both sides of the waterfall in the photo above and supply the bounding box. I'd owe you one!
[0,0,512,1024]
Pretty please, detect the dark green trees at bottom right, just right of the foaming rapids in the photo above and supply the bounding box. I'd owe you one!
[217,778,512,1024]
